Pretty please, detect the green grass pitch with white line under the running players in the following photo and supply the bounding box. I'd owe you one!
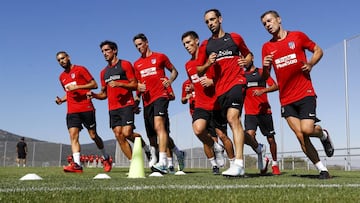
[0,167,360,203]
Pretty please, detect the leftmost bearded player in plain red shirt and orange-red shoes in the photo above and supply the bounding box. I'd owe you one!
[55,51,112,173]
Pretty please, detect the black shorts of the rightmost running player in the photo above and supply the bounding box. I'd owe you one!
[281,96,320,122]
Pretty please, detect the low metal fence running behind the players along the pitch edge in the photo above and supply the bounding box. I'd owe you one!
[0,141,360,170]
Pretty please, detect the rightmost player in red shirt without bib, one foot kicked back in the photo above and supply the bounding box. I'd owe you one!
[260,10,334,179]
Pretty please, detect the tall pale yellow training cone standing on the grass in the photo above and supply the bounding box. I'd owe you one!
[128,137,145,178]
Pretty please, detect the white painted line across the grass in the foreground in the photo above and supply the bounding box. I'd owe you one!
[0,184,360,193]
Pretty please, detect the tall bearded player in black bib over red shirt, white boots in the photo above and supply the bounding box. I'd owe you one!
[197,9,250,177]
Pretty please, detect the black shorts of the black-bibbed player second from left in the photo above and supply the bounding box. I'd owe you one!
[109,106,134,128]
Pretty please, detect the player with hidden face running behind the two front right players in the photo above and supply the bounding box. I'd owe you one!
[244,53,280,175]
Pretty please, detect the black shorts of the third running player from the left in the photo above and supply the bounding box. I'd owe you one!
[144,98,170,137]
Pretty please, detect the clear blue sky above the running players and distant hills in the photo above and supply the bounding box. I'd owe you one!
[0,0,360,155]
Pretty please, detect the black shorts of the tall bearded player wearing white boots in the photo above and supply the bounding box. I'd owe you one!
[217,85,244,118]
